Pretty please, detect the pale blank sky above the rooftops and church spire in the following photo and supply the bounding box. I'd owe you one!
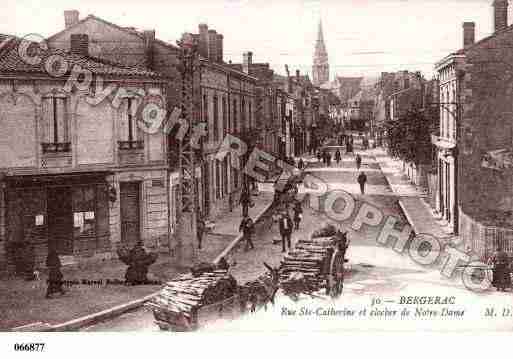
[0,0,504,79]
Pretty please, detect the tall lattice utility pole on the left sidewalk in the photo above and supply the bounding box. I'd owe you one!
[177,34,199,266]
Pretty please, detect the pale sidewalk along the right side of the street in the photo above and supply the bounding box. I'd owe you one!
[367,148,453,243]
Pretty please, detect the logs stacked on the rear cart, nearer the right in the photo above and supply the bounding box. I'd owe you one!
[280,237,334,294]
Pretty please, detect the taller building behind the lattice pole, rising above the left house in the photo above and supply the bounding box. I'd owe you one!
[48,14,256,245]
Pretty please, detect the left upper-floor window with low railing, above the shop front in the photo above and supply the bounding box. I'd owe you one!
[42,96,71,153]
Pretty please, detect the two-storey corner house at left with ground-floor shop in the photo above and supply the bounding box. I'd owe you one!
[0,35,168,271]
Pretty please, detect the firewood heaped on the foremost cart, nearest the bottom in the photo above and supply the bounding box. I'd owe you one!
[149,270,237,318]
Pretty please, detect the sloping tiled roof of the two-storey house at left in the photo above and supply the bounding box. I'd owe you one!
[0,35,159,78]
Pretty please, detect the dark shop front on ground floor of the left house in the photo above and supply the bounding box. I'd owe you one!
[3,172,111,272]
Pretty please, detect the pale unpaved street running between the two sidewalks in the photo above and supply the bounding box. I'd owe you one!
[84,143,511,331]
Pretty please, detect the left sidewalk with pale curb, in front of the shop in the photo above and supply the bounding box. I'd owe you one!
[0,192,273,331]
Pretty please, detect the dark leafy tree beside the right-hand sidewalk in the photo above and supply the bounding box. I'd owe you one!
[385,107,433,166]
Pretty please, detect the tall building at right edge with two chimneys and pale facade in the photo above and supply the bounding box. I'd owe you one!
[433,0,513,258]
